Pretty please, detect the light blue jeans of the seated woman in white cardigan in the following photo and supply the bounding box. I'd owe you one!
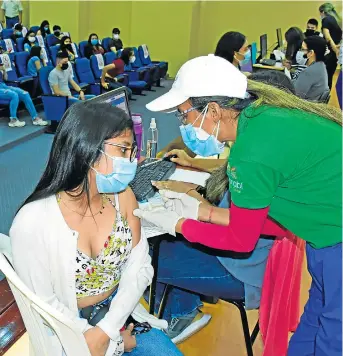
[124,329,183,356]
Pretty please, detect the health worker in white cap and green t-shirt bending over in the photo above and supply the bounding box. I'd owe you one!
[134,55,342,356]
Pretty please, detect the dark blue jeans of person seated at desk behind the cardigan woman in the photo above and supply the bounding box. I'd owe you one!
[149,241,244,321]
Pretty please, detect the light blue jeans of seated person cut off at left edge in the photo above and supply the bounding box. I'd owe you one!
[0,83,37,120]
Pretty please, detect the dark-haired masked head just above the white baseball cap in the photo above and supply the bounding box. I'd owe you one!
[214,31,251,68]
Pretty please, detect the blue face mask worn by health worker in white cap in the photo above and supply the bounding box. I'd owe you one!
[180,105,224,157]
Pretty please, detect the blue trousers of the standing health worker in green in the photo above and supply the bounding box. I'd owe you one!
[288,243,342,356]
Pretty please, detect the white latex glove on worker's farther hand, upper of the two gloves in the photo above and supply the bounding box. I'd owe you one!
[159,190,200,220]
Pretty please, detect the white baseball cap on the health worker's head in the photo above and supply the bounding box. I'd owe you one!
[146,54,247,112]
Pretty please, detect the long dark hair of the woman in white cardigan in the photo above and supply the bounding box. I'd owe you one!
[23,100,133,209]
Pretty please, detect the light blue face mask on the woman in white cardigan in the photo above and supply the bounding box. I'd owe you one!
[92,151,137,193]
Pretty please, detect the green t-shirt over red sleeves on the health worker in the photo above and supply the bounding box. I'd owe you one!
[228,106,342,248]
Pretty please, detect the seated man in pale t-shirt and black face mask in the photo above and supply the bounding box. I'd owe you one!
[49,51,94,104]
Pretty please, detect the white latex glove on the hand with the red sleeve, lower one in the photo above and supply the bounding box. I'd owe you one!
[133,206,182,236]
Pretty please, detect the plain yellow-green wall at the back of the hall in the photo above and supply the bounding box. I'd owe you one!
[23,0,342,76]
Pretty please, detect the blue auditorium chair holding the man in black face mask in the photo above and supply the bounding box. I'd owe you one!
[38,66,68,133]
